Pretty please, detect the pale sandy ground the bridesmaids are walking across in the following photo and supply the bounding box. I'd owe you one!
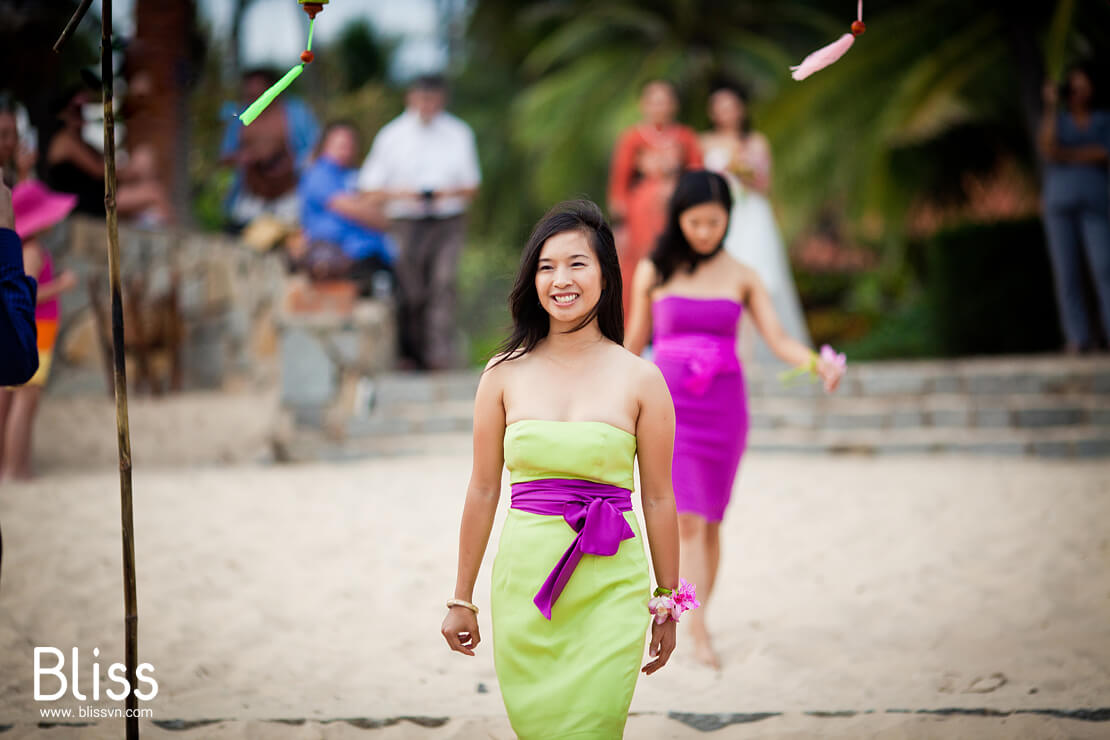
[0,455,1110,740]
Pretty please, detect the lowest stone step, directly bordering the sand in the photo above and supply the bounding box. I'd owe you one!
[294,425,1110,460]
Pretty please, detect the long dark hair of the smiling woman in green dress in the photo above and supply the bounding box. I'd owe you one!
[494,200,624,366]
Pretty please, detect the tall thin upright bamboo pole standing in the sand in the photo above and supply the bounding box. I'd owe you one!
[100,0,139,740]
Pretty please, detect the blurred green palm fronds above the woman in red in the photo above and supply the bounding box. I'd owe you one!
[512,0,827,210]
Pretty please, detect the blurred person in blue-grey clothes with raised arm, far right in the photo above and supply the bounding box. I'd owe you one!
[1038,65,1110,354]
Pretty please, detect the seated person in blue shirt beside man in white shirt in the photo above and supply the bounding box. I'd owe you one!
[296,121,393,295]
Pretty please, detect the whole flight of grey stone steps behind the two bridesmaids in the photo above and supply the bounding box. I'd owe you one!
[315,356,1110,457]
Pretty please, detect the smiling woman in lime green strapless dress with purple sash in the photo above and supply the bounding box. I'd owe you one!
[442,201,682,740]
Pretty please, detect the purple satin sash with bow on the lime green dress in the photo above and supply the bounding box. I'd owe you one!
[512,478,636,619]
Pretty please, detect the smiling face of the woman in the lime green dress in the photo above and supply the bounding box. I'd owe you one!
[536,231,603,324]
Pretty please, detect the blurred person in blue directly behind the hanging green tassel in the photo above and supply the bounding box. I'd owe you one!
[220,69,320,231]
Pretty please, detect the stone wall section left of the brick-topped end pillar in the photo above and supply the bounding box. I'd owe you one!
[48,217,286,395]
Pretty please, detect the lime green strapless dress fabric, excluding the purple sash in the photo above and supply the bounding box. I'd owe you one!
[491,420,650,740]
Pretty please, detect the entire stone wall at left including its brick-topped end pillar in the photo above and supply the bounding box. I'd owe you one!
[47,219,406,436]
